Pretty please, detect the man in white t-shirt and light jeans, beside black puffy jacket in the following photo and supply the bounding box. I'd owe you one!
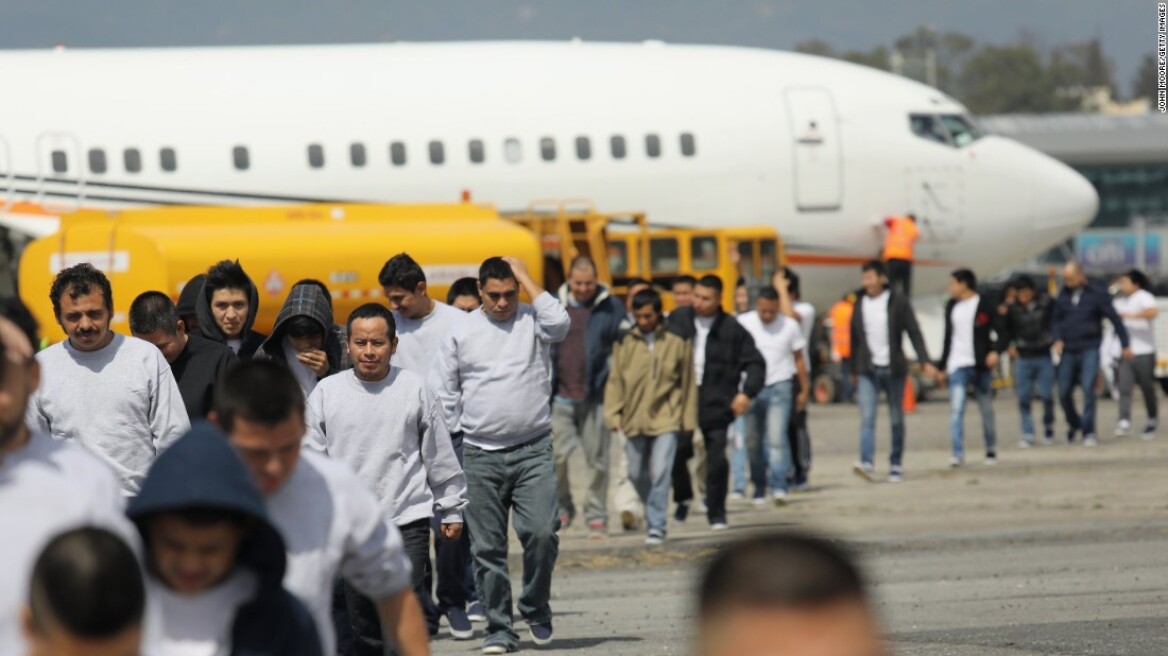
[738,287,811,505]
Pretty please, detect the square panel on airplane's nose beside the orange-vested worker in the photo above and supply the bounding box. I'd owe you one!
[906,166,965,244]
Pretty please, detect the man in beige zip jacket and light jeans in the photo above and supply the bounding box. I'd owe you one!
[604,289,697,545]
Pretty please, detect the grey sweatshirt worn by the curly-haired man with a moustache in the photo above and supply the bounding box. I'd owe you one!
[27,334,190,496]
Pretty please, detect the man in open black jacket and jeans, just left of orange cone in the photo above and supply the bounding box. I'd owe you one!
[851,260,936,483]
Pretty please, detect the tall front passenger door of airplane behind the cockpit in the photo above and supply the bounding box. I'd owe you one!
[785,88,843,211]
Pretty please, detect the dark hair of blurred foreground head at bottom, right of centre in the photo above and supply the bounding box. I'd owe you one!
[698,532,867,620]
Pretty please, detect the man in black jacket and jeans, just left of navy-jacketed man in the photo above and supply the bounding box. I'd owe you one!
[1001,275,1055,448]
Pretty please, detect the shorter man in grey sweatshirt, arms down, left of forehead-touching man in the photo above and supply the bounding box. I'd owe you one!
[305,303,474,643]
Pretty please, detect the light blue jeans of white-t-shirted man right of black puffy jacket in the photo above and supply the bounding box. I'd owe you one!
[746,381,794,490]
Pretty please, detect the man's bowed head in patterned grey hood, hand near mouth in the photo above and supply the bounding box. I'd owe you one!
[259,282,343,397]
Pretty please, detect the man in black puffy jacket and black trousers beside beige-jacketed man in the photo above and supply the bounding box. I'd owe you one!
[668,275,766,530]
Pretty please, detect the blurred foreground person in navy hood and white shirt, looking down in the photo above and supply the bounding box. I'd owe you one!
[126,423,322,656]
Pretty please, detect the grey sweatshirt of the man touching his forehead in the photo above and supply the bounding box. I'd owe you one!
[434,292,571,451]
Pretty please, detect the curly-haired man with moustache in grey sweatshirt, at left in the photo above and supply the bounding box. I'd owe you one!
[28,264,190,496]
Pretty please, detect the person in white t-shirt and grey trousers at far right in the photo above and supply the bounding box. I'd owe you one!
[1115,268,1160,440]
